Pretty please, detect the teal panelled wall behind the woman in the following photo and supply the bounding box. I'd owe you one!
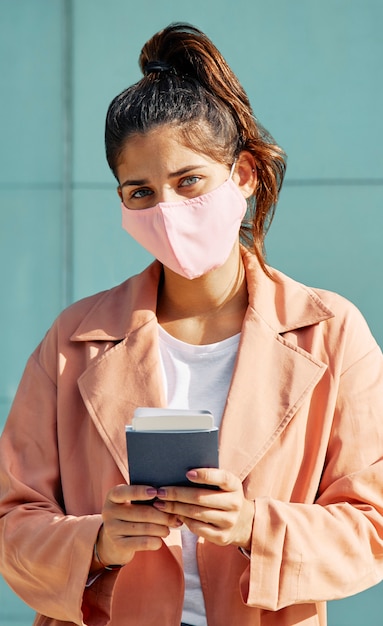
[0,0,383,626]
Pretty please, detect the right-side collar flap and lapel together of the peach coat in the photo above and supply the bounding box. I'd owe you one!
[220,250,333,480]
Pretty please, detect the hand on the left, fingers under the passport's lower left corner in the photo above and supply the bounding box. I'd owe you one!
[91,485,182,571]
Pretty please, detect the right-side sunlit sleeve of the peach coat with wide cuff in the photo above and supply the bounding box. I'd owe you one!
[240,302,383,611]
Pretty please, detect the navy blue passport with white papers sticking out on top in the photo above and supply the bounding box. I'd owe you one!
[126,407,218,489]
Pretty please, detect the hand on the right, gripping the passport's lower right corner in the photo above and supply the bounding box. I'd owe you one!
[153,468,254,550]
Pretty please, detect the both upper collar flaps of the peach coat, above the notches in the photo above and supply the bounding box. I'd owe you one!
[71,248,333,341]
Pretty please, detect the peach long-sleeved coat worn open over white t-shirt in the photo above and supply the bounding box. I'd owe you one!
[0,253,383,626]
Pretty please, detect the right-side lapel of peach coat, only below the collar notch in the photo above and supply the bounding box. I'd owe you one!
[220,311,326,480]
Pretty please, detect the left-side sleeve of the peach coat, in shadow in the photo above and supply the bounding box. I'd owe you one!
[0,352,114,625]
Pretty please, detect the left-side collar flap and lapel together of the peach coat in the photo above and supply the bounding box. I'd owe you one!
[71,263,165,481]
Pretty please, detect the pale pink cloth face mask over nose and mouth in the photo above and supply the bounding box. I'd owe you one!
[121,175,247,279]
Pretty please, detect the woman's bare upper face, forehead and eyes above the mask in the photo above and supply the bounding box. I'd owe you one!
[117,126,230,209]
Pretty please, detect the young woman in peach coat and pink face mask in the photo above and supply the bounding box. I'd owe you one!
[0,24,383,626]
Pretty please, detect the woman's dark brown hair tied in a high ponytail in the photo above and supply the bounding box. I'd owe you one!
[105,23,286,273]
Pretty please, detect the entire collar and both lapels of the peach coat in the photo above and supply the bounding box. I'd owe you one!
[71,251,333,480]
